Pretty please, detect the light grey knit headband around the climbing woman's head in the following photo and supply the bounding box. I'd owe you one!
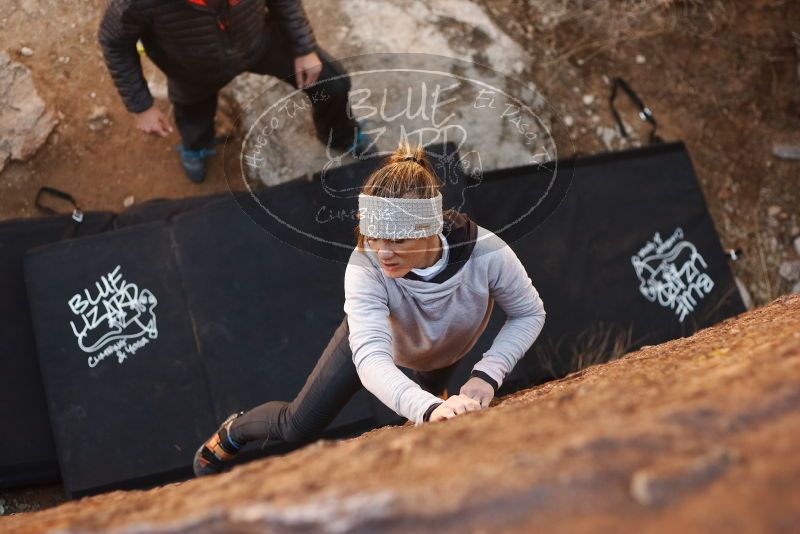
[358,193,444,239]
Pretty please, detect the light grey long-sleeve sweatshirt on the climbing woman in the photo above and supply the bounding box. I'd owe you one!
[344,226,545,424]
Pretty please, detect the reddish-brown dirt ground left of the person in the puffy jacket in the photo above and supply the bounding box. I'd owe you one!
[0,0,241,220]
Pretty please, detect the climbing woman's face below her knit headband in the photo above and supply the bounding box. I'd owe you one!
[366,235,442,278]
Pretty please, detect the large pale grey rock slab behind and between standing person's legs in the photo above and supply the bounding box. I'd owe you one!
[223,0,552,185]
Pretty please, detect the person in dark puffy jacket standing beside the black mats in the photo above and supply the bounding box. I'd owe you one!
[98,0,371,182]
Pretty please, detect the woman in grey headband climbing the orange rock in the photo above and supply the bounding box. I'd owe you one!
[194,146,545,476]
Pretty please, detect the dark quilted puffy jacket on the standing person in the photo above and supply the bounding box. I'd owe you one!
[98,0,316,113]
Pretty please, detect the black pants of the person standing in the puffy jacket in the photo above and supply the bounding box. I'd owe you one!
[167,18,356,150]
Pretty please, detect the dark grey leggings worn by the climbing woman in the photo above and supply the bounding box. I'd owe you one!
[230,317,456,444]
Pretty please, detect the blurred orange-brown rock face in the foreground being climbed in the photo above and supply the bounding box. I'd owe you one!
[0,296,800,533]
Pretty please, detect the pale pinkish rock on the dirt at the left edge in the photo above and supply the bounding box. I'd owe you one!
[0,52,58,171]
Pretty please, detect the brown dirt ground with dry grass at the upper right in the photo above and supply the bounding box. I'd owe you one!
[482,0,800,304]
